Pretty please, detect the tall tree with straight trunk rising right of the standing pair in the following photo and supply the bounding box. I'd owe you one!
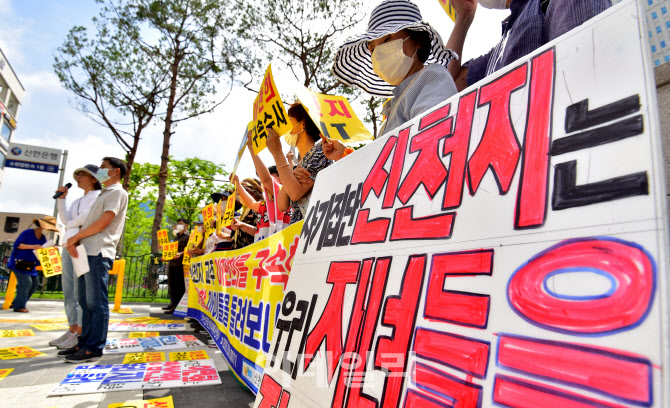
[98,0,238,252]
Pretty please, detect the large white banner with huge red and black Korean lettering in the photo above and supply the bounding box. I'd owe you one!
[255,1,670,408]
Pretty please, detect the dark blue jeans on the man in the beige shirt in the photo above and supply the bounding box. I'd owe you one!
[77,254,113,354]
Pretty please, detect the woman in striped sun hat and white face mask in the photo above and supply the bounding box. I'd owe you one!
[334,0,476,140]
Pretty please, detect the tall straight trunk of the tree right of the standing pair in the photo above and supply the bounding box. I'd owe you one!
[151,51,181,253]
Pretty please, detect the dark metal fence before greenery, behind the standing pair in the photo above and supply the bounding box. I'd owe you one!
[0,243,168,300]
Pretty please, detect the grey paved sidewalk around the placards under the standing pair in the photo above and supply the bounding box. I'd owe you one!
[0,300,255,408]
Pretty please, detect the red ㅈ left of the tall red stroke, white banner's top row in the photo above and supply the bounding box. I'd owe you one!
[468,64,527,195]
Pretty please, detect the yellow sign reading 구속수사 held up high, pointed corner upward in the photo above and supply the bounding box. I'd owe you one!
[251,64,292,153]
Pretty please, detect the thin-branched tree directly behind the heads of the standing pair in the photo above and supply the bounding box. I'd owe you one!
[53,10,167,190]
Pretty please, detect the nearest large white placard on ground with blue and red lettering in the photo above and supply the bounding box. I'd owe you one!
[49,360,221,395]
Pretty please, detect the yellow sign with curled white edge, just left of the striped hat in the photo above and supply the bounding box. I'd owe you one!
[296,87,374,143]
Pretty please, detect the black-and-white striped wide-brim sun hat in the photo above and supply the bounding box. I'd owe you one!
[332,0,458,98]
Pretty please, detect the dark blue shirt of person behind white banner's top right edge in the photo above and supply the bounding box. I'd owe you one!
[464,0,612,85]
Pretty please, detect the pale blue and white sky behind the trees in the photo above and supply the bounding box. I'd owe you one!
[0,0,508,218]
